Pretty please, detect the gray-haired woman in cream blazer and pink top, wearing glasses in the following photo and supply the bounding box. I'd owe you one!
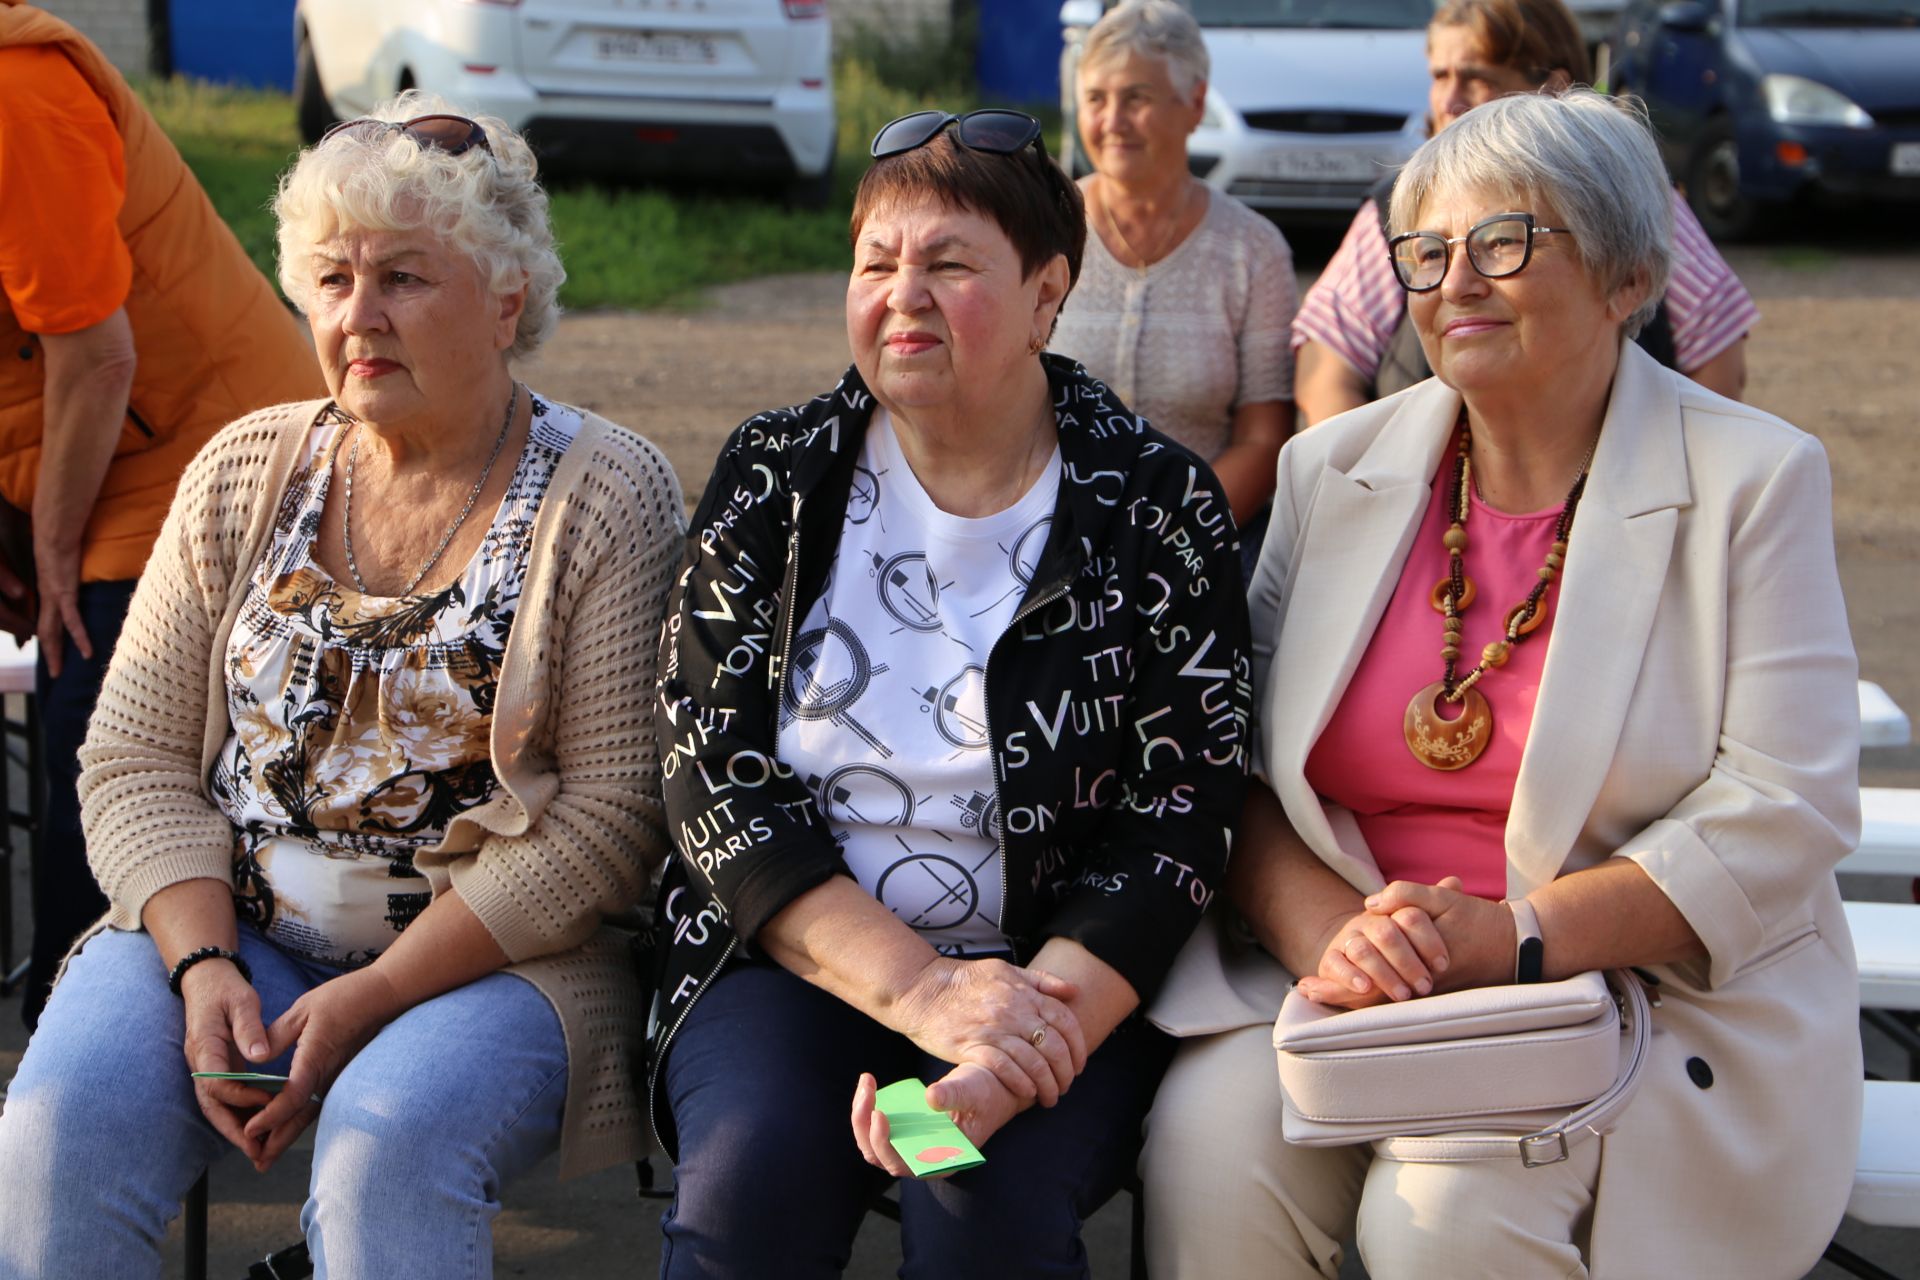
[1142,90,1860,1280]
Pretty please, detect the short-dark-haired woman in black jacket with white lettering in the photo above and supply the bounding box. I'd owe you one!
[651,111,1252,1280]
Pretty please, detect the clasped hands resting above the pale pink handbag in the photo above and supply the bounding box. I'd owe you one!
[1300,875,1513,1009]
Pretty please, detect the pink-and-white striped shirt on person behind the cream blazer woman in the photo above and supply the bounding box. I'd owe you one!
[1292,192,1761,382]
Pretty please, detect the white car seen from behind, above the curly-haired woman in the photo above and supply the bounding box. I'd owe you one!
[294,0,833,203]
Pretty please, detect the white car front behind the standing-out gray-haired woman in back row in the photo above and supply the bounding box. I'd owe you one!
[1060,0,1434,221]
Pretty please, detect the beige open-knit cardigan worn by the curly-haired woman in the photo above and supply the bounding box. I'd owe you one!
[79,401,685,1178]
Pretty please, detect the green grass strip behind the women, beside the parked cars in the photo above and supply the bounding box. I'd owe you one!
[138,40,998,307]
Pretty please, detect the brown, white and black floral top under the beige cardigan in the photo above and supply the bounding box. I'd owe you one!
[207,397,582,967]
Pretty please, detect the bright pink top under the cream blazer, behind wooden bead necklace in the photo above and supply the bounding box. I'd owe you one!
[1308,449,1580,900]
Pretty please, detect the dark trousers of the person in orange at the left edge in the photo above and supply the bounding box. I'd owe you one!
[19,580,134,1032]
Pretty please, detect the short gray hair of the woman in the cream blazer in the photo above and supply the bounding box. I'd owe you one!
[1388,88,1674,338]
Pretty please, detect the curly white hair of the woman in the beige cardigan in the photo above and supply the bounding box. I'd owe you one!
[273,88,566,359]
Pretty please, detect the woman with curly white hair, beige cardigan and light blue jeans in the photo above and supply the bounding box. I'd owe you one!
[0,94,682,1276]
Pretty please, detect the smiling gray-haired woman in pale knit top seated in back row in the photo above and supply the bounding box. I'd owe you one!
[1048,0,1298,549]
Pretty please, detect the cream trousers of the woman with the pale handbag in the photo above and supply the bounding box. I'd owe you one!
[1140,1025,1601,1280]
